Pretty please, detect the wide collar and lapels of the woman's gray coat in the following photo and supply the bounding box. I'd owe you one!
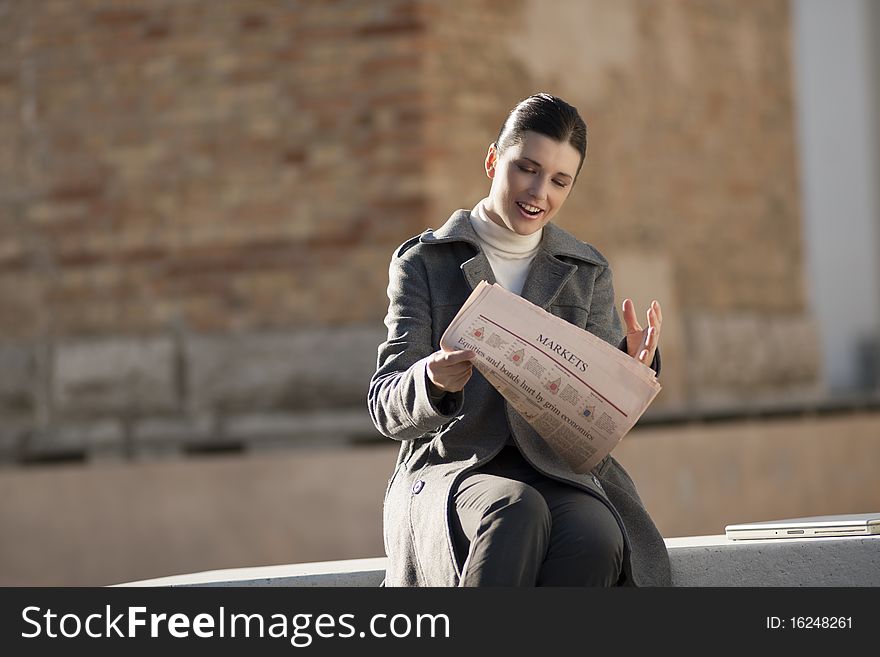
[419,210,606,309]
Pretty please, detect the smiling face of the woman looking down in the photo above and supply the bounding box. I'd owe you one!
[486,131,581,235]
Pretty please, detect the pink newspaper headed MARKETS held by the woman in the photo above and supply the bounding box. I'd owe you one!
[440,281,660,473]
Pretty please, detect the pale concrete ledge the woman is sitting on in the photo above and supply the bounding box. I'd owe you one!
[117,535,880,587]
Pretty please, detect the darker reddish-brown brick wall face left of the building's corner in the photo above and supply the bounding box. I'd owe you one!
[0,0,425,338]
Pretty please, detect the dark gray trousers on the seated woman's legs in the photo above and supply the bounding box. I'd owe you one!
[451,445,623,586]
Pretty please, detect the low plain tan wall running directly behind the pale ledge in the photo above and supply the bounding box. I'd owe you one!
[0,413,880,586]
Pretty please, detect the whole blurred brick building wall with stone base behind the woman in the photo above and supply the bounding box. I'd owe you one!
[0,0,818,462]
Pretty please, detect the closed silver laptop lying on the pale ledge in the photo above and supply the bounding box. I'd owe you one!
[724,513,880,541]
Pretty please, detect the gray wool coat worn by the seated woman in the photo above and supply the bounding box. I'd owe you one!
[367,210,671,586]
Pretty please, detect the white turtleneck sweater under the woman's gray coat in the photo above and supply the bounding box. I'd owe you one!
[471,199,544,294]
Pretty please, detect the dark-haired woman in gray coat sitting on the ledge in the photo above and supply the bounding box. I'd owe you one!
[368,94,670,586]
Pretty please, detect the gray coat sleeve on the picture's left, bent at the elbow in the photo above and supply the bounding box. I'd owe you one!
[367,256,464,440]
